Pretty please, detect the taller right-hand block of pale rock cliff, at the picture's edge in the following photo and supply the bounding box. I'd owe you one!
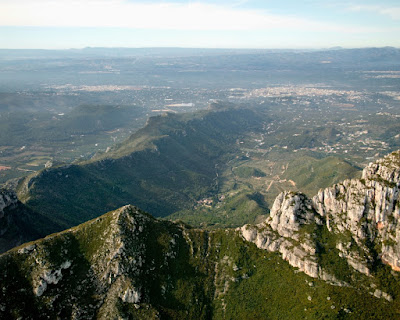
[313,152,400,274]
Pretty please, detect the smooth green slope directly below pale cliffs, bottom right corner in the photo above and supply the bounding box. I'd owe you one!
[220,240,397,320]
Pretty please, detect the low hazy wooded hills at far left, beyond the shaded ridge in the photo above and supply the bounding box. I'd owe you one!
[0,105,143,147]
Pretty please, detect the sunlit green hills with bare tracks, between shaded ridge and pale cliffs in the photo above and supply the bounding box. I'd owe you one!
[167,152,361,228]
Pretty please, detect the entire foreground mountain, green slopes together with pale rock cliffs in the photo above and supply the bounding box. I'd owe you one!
[0,151,400,319]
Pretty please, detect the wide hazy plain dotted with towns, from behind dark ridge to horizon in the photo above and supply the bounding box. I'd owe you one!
[0,48,400,183]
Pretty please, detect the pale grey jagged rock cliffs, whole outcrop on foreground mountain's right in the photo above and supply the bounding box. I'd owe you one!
[240,151,400,292]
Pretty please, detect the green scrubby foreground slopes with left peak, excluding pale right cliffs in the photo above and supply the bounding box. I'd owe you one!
[0,208,399,320]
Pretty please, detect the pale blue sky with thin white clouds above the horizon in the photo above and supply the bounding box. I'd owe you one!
[0,0,400,49]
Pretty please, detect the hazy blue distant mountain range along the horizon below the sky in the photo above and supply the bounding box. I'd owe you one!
[0,47,400,68]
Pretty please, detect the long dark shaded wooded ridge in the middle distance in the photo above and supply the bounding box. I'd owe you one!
[12,108,261,228]
